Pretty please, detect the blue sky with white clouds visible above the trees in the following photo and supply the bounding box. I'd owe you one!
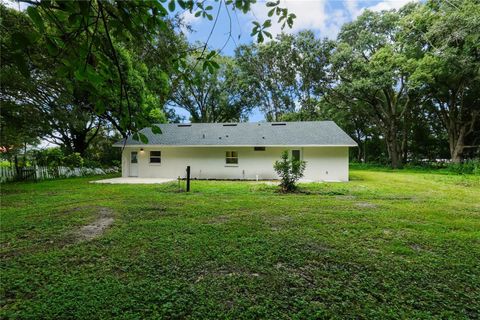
[176,0,412,122]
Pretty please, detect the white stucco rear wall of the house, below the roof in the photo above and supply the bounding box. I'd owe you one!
[122,147,348,181]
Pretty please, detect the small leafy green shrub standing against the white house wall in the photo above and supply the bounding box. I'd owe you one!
[273,150,306,192]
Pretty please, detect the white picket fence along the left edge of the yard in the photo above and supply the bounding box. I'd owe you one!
[0,166,119,183]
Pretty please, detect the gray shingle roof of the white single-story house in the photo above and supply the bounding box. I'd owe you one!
[114,121,357,147]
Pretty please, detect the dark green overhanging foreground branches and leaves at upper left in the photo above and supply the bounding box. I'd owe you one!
[15,0,295,140]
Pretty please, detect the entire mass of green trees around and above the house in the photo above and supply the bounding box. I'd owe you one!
[0,0,480,168]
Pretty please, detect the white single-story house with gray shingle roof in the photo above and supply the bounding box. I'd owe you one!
[114,121,357,181]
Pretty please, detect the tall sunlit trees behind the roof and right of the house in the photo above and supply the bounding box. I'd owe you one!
[169,0,480,168]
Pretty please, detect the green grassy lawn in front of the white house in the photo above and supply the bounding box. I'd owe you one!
[0,170,480,319]
